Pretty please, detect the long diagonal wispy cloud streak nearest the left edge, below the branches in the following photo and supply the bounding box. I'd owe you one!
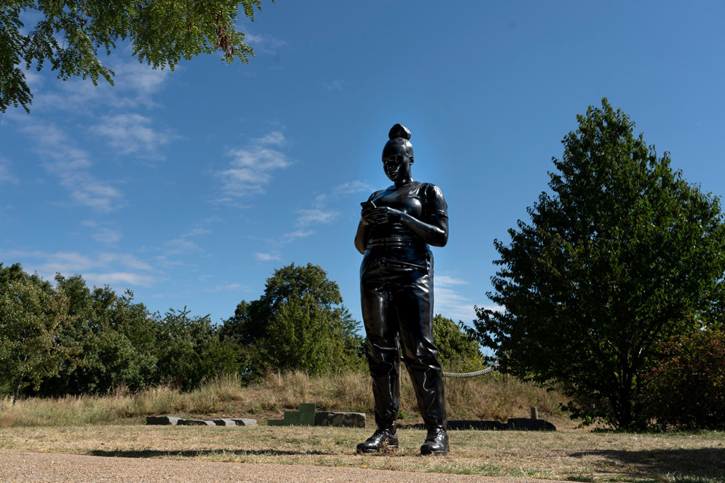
[21,122,123,212]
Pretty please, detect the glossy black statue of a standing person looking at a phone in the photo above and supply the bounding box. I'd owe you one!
[355,124,448,454]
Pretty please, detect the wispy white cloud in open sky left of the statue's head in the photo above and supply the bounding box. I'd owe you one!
[215,131,292,203]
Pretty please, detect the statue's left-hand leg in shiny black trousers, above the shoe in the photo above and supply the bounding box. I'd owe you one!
[361,283,400,429]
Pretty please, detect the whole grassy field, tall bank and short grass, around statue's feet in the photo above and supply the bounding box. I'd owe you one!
[0,374,725,483]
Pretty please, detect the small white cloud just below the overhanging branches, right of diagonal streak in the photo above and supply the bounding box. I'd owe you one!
[90,114,176,158]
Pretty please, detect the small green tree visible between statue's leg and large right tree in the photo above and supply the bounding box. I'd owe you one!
[433,314,485,372]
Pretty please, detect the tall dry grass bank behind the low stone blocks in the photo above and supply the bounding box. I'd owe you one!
[0,372,566,427]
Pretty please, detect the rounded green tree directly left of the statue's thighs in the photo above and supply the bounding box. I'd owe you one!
[221,263,362,376]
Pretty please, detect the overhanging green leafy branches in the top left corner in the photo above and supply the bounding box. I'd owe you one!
[0,0,261,112]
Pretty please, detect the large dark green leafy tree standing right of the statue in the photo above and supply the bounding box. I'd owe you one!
[474,99,725,428]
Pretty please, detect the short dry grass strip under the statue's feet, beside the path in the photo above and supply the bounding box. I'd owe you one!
[0,425,725,483]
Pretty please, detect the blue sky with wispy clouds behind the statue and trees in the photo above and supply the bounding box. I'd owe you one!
[0,0,725,328]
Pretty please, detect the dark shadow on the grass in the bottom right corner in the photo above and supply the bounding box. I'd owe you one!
[569,448,725,482]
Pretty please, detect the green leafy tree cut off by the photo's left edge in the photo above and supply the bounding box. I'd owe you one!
[0,267,75,404]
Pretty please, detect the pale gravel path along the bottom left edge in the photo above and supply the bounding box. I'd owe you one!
[0,449,542,483]
